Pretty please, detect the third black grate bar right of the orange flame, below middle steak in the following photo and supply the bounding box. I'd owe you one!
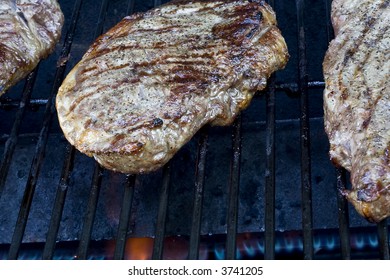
[226,116,242,260]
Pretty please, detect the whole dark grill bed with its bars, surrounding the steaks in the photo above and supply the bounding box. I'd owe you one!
[0,0,389,259]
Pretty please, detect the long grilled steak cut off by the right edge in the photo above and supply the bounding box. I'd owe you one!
[323,0,390,222]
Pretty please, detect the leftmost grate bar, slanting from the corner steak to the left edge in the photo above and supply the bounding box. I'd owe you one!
[0,68,39,197]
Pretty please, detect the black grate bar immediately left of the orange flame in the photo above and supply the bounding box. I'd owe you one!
[114,175,136,260]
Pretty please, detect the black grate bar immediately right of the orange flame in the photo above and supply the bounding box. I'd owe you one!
[152,162,171,260]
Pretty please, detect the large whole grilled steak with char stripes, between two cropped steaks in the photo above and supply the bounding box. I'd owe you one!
[56,0,288,173]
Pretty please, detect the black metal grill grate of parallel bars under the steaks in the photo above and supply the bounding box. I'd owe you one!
[0,0,389,259]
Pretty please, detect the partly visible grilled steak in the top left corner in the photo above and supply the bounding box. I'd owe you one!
[0,0,64,95]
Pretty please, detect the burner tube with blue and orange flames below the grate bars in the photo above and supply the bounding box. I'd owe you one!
[0,228,386,260]
